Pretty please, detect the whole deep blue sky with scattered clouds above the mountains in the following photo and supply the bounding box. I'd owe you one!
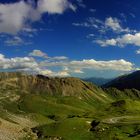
[0,0,140,78]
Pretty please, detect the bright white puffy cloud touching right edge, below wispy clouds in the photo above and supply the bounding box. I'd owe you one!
[97,33,140,46]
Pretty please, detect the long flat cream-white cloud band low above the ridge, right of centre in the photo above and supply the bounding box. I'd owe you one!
[40,59,134,72]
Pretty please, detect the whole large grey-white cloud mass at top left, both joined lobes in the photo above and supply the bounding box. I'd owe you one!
[0,0,76,34]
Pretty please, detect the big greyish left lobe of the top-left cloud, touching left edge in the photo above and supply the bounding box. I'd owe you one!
[0,1,40,34]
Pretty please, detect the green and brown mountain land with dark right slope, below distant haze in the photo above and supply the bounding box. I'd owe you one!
[0,71,140,140]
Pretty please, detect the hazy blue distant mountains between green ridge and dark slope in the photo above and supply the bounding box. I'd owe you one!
[82,77,112,86]
